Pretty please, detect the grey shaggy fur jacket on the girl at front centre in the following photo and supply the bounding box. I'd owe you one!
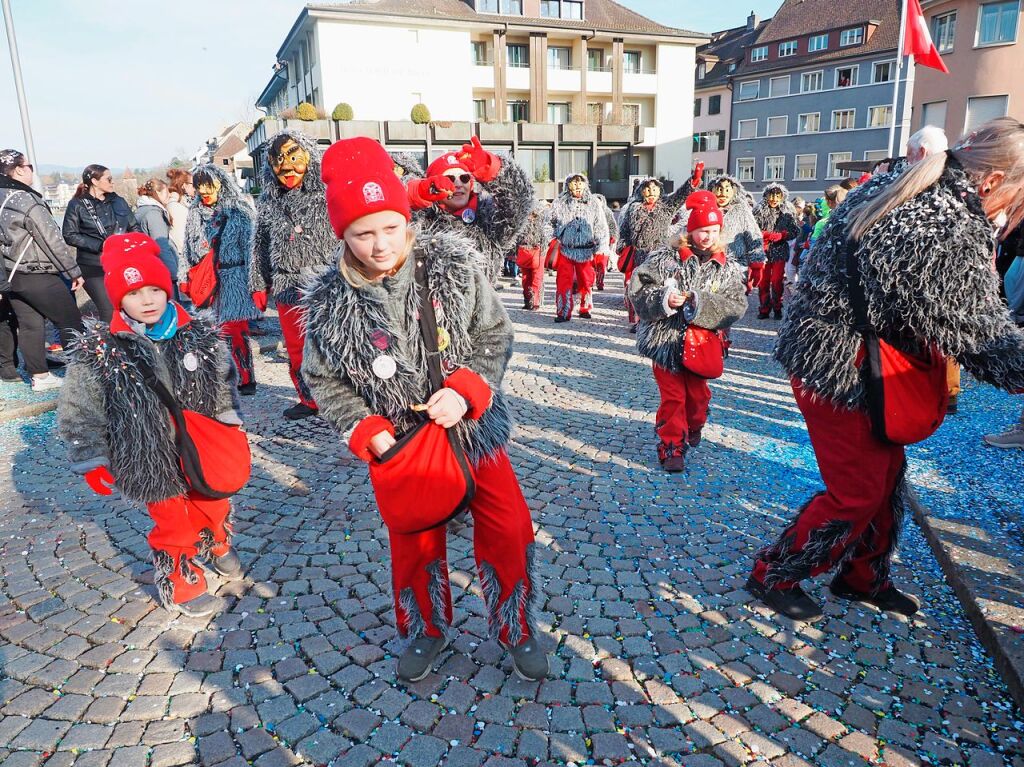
[302,232,513,464]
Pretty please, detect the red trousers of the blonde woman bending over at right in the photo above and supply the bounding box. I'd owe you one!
[754,382,906,594]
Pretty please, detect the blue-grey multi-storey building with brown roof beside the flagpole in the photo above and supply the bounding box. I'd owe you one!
[729,0,914,197]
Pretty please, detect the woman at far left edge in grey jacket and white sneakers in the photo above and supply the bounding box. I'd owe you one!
[0,150,84,391]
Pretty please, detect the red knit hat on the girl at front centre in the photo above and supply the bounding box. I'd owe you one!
[321,137,412,240]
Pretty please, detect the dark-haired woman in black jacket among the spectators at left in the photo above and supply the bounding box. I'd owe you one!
[62,165,138,323]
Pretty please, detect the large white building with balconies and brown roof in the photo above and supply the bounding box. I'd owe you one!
[249,0,707,200]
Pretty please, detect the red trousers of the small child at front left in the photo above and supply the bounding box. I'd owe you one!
[146,493,231,604]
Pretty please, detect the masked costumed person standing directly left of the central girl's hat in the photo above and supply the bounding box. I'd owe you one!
[252,131,337,421]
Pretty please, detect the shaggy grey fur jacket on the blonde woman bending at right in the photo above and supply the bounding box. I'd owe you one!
[775,162,1024,408]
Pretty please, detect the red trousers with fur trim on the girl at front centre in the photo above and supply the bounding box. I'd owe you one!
[389,451,536,645]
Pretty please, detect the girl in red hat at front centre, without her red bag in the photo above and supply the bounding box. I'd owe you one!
[303,138,548,682]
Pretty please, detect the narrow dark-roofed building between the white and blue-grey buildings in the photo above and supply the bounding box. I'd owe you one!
[693,13,768,178]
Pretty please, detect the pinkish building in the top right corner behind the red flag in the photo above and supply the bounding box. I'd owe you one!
[912,0,1024,143]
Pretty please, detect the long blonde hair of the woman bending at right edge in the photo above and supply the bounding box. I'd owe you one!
[847,117,1024,241]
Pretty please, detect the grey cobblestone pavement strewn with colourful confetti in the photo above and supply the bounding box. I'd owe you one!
[0,275,1024,767]
